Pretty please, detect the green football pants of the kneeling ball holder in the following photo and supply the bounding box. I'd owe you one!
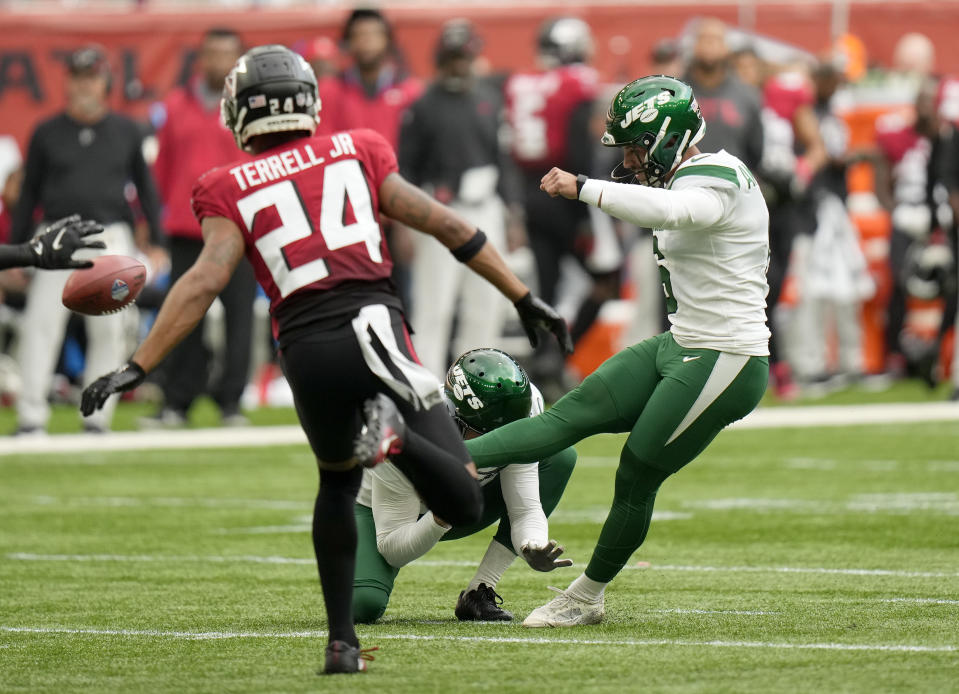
[353,448,576,624]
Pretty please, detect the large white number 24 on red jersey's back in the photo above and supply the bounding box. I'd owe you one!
[237,159,383,298]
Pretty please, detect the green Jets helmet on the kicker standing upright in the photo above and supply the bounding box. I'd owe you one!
[602,75,706,188]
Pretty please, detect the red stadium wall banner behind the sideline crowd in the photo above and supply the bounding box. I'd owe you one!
[0,0,959,147]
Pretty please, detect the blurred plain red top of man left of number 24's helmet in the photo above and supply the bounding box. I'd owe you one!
[153,83,246,241]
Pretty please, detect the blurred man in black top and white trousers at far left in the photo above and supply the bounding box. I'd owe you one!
[11,46,160,434]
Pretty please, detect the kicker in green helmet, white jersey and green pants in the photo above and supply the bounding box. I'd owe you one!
[467,77,769,627]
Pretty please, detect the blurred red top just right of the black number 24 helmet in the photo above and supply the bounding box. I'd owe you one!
[317,71,423,150]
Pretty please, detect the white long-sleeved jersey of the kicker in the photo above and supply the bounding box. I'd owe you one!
[580,151,769,356]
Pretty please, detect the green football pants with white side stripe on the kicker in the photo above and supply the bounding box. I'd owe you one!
[466,332,769,583]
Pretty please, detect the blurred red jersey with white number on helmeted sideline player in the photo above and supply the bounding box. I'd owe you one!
[504,65,599,170]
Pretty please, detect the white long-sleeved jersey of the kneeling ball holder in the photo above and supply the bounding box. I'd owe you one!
[356,385,549,567]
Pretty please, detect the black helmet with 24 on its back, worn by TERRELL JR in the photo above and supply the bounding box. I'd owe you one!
[220,45,320,150]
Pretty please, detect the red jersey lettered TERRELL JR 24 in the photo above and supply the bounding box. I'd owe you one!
[193,130,399,336]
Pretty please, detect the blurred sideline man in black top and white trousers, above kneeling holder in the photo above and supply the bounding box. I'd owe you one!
[398,20,519,377]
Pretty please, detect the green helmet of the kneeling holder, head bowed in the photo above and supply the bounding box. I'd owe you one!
[443,349,533,434]
